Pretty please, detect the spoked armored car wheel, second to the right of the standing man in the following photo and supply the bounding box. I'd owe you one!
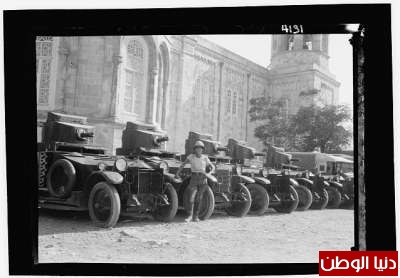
[226,183,252,217]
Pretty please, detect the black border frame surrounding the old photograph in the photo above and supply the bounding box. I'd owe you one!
[3,4,396,276]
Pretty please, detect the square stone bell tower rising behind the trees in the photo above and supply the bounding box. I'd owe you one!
[268,34,340,114]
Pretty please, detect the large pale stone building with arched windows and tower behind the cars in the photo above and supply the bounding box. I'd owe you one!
[36,35,339,153]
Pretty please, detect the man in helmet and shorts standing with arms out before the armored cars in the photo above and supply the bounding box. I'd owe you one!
[176,141,215,222]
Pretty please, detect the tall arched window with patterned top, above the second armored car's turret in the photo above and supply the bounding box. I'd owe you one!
[123,37,148,120]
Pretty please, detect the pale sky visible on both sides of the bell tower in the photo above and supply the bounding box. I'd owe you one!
[202,34,353,108]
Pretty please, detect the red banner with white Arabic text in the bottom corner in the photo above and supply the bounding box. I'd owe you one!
[319,251,398,276]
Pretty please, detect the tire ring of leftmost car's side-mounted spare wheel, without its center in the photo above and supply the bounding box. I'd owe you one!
[46,159,76,199]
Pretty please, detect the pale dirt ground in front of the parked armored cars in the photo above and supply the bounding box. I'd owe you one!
[38,209,354,263]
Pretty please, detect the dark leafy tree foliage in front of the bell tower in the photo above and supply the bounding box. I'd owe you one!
[249,97,352,152]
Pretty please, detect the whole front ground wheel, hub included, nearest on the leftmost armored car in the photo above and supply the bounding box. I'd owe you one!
[88,182,121,228]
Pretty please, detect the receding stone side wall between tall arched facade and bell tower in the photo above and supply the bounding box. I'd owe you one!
[166,36,268,152]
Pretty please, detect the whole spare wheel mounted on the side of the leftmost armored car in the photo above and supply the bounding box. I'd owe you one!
[46,159,76,198]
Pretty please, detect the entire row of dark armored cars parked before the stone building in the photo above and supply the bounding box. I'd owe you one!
[38,112,354,227]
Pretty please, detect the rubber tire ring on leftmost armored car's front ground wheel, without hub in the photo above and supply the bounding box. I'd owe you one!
[88,181,121,228]
